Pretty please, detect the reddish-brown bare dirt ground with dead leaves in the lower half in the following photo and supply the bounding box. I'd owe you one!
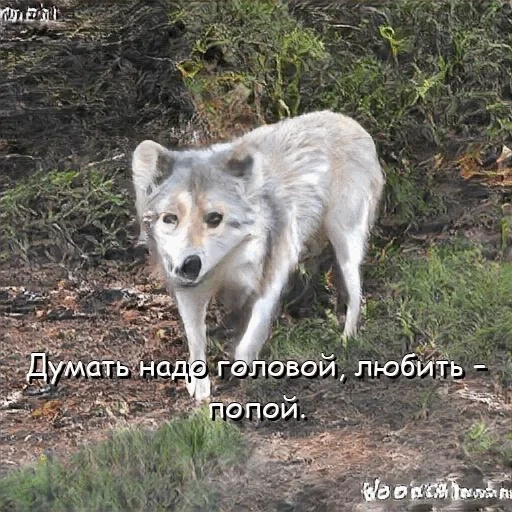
[0,261,512,511]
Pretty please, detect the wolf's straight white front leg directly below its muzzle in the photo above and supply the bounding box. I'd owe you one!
[175,289,211,401]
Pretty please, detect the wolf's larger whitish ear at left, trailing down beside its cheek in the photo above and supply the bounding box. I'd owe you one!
[132,140,175,245]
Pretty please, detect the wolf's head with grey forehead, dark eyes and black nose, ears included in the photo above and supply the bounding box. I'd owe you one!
[132,140,261,286]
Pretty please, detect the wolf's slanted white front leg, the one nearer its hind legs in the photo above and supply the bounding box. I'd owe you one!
[235,260,296,364]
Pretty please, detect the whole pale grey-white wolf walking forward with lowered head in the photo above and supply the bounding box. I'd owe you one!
[132,111,385,400]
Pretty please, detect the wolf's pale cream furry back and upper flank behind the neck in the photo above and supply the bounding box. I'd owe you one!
[235,111,384,230]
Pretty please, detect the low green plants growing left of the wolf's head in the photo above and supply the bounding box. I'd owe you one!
[0,169,131,260]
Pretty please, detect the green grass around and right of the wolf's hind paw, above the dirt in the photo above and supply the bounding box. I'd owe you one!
[270,243,512,364]
